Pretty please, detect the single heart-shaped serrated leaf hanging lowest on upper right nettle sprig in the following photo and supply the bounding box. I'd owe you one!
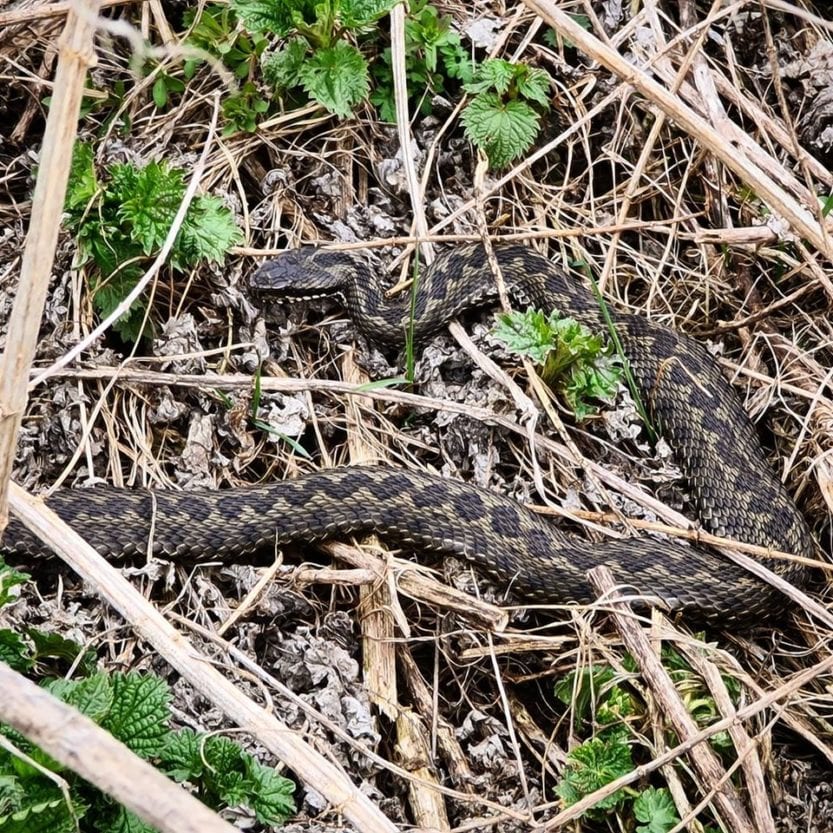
[462,92,539,168]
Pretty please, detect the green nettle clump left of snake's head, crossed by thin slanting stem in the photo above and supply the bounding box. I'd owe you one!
[65,142,243,341]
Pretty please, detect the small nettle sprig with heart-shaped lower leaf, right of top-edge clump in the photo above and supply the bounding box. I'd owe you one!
[461,58,552,168]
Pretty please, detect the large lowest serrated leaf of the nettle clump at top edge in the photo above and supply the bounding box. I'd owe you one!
[300,41,370,118]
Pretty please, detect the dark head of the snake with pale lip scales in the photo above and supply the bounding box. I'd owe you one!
[249,246,352,300]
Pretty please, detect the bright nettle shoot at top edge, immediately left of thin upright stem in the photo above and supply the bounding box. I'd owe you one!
[250,0,395,118]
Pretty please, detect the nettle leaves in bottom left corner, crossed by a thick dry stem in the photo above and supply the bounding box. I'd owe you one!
[0,672,295,833]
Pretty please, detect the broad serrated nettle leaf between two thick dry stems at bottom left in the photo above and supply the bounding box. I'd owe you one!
[102,673,171,758]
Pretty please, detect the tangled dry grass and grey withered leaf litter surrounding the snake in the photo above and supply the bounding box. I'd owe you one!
[0,2,833,833]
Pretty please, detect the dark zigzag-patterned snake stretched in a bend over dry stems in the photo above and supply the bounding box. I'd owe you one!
[3,244,813,628]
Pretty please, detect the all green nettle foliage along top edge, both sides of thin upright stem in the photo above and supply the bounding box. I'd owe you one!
[182,0,474,128]
